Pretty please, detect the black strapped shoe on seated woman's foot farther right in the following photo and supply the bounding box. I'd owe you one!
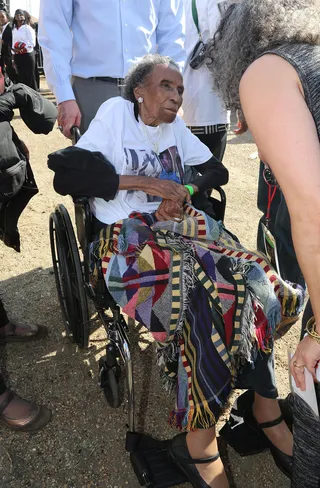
[245,410,293,479]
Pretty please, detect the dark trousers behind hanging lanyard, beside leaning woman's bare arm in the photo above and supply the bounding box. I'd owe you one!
[257,162,305,287]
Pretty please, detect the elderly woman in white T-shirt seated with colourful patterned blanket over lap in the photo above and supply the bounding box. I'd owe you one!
[49,55,304,488]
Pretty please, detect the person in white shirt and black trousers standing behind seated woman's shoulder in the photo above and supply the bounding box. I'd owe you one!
[182,0,230,162]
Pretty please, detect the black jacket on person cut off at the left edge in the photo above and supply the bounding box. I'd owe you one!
[0,84,57,252]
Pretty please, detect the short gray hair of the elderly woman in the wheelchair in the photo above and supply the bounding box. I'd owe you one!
[123,54,179,103]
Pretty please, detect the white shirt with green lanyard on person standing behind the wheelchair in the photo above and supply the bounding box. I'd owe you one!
[182,0,230,127]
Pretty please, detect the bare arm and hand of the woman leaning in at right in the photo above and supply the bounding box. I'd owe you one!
[240,55,320,388]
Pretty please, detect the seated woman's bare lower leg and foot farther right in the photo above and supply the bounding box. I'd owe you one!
[252,393,293,456]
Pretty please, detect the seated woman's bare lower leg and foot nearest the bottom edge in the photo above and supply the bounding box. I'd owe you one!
[187,427,229,488]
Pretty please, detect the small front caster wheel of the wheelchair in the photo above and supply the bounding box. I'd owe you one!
[99,356,123,408]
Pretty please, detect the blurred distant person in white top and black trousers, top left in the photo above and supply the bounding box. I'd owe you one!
[12,9,39,90]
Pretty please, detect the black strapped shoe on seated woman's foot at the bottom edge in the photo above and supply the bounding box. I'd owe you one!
[168,432,220,488]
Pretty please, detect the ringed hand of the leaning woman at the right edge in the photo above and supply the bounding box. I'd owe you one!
[290,336,320,391]
